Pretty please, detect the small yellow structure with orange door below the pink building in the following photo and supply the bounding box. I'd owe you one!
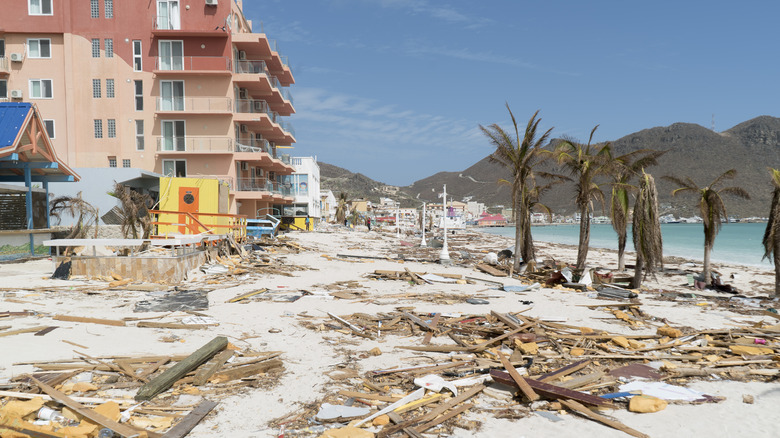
[157,177,230,235]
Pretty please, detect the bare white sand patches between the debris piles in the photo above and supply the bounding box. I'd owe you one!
[0,231,780,438]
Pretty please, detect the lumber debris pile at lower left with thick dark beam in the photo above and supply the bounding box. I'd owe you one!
[0,336,284,438]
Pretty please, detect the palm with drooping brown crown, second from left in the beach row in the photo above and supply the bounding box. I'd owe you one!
[553,125,611,269]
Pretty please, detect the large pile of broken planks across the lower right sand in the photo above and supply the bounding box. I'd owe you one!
[282,303,780,437]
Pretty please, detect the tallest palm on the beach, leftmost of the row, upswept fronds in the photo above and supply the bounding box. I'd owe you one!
[479,103,553,271]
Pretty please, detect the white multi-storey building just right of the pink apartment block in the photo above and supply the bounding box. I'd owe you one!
[283,157,322,221]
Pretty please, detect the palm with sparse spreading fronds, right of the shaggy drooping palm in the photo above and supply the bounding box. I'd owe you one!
[664,169,750,286]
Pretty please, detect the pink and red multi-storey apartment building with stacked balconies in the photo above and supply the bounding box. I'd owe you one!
[0,0,295,217]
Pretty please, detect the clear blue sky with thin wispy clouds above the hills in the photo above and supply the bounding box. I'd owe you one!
[244,0,780,186]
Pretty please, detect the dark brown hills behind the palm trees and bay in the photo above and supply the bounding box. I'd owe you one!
[404,116,780,217]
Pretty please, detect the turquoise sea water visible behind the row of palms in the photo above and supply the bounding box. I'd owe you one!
[480,223,774,268]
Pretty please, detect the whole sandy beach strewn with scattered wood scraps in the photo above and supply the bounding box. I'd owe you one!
[0,226,780,438]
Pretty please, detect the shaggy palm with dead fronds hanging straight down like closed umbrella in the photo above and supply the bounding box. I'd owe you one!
[631,170,663,288]
